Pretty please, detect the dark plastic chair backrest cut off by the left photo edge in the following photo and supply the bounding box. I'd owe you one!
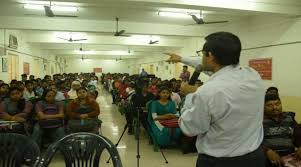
[0,133,40,167]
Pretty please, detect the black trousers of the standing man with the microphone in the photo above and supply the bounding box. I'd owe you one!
[196,148,265,167]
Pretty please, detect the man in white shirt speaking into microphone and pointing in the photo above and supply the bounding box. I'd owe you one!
[165,32,265,167]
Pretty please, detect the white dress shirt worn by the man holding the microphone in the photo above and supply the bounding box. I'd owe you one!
[179,66,265,157]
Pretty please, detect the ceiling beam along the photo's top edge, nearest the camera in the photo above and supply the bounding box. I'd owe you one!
[17,0,301,15]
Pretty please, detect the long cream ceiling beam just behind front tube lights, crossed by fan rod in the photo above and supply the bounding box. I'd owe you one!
[0,16,202,37]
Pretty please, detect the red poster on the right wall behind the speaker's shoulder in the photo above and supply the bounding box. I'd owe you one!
[249,58,272,80]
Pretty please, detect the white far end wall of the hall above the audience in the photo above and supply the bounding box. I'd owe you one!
[66,59,130,73]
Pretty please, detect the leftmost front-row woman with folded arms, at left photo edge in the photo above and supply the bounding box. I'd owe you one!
[0,87,32,134]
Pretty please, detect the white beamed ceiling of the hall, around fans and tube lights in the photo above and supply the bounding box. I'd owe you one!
[0,0,301,59]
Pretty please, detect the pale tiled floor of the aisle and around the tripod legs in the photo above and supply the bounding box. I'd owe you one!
[51,87,197,167]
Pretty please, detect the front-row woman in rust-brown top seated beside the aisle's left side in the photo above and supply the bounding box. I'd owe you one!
[67,87,101,133]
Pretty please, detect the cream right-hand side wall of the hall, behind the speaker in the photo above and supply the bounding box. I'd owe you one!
[131,16,301,122]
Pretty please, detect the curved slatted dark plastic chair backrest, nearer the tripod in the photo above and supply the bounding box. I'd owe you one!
[39,132,122,167]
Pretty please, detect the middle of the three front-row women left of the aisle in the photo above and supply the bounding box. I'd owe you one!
[32,89,65,145]
